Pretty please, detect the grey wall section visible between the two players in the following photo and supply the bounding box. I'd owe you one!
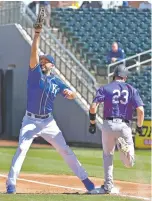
[54,96,101,144]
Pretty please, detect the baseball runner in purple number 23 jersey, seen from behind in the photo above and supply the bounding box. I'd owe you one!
[89,65,144,194]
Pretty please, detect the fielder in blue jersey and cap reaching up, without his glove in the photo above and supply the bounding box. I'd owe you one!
[6,21,94,194]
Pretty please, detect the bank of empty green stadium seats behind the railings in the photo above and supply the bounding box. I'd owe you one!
[52,8,151,75]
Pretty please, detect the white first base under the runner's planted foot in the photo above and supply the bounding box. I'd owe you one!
[87,185,119,194]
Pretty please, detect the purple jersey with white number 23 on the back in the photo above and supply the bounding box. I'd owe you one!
[93,81,144,120]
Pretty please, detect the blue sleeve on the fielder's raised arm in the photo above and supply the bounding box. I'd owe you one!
[28,64,42,83]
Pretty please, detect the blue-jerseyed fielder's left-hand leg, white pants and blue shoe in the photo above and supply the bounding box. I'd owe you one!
[6,116,37,193]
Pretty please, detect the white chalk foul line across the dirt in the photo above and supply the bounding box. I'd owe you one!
[0,174,151,201]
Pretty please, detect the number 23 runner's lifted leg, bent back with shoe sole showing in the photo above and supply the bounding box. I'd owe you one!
[117,123,135,168]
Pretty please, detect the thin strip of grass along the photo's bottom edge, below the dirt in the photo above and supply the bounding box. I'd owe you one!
[0,194,141,201]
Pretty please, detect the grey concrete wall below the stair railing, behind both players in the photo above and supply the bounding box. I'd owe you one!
[0,25,101,144]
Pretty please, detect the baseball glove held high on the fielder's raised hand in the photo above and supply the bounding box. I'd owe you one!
[34,7,46,29]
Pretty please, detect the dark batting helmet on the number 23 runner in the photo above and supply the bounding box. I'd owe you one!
[113,64,129,78]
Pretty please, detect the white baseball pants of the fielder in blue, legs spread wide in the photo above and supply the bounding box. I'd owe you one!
[6,115,88,185]
